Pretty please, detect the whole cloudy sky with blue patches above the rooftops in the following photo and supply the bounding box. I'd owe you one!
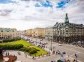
[0,0,84,30]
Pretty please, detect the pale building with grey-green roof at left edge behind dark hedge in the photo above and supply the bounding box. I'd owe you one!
[0,28,19,40]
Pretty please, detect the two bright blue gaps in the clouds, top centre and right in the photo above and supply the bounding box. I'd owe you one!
[35,0,70,8]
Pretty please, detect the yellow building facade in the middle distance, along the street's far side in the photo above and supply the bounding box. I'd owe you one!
[25,28,45,38]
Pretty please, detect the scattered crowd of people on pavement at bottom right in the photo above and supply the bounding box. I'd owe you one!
[51,50,79,62]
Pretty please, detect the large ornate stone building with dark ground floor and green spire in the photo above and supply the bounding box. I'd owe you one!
[53,14,84,43]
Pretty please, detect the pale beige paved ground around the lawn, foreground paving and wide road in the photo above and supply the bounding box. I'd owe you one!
[0,38,84,62]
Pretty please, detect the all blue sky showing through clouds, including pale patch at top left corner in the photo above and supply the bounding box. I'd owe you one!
[0,0,70,8]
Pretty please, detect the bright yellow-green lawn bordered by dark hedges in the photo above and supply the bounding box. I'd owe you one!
[0,39,47,56]
